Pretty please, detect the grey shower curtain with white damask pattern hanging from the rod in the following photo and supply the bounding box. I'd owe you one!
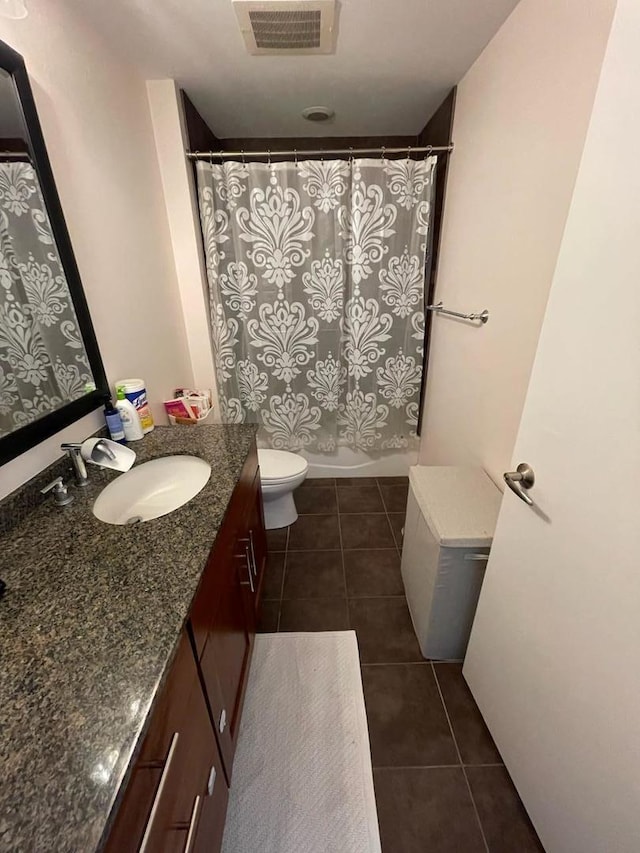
[197,157,436,453]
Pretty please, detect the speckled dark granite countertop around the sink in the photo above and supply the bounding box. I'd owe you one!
[0,426,255,853]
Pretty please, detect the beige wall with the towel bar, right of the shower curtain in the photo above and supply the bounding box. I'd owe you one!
[420,0,615,483]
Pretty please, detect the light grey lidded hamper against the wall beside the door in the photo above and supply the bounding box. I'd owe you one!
[401,465,502,660]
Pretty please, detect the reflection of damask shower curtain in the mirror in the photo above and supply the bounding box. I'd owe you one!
[0,161,93,437]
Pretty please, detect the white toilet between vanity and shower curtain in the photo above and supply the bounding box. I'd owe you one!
[258,450,309,530]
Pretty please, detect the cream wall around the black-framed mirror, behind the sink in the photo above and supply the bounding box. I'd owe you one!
[0,5,193,497]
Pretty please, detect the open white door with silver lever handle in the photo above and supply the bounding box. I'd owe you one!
[464,0,640,853]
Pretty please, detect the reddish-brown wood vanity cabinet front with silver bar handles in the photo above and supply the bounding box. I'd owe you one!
[105,447,267,853]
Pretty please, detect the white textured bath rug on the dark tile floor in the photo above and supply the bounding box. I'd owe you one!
[223,631,381,853]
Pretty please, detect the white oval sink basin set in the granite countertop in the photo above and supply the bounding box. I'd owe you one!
[93,456,211,524]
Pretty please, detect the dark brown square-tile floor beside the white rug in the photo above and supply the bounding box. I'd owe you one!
[260,477,543,853]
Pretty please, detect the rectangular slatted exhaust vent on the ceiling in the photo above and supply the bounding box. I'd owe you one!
[233,0,335,56]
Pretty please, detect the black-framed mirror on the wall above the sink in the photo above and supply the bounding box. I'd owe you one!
[0,42,108,465]
